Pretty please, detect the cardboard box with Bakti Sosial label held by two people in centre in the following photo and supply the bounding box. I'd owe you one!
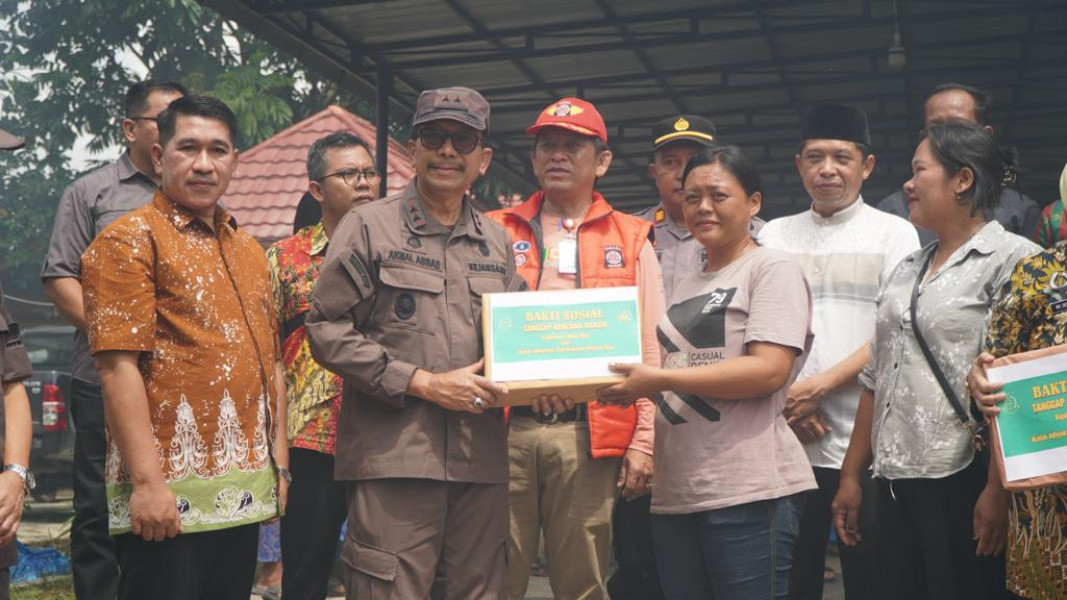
[481,287,641,405]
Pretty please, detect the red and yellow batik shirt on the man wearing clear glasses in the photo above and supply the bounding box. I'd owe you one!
[267,222,341,455]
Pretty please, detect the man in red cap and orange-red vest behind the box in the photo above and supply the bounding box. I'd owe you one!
[489,98,664,600]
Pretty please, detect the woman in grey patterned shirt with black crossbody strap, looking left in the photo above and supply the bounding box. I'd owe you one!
[833,123,1038,600]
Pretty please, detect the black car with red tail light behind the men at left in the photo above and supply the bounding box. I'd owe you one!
[22,326,74,502]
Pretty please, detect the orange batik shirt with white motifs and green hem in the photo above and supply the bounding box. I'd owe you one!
[81,192,278,534]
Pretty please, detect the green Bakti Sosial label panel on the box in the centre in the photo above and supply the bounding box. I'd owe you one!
[493,300,641,363]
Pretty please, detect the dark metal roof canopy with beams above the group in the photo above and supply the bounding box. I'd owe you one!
[201,0,1067,217]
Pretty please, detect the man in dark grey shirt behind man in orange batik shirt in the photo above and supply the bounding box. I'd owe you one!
[41,81,186,600]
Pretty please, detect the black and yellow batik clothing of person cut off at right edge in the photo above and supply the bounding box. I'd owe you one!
[985,244,1067,599]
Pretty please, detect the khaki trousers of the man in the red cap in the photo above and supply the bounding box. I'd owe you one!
[508,416,621,600]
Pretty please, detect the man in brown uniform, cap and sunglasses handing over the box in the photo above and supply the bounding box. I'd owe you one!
[307,88,523,600]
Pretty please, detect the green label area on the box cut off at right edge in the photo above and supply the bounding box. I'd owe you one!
[997,373,1067,457]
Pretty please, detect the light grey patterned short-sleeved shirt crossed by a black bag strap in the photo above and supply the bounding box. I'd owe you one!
[859,221,1039,479]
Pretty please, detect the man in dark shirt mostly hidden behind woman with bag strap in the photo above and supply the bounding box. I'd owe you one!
[875,83,1041,246]
